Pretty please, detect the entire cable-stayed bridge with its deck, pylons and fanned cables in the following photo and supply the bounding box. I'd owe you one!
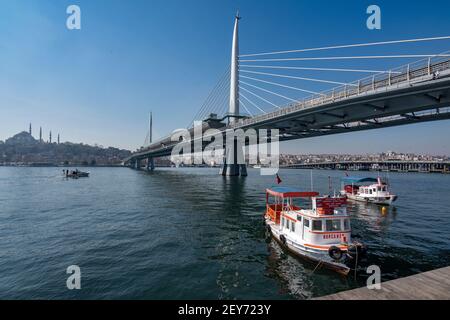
[124,16,450,175]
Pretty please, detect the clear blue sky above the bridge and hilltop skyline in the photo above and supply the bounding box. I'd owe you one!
[0,0,450,155]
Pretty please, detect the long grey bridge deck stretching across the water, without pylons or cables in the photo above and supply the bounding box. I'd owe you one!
[124,56,450,163]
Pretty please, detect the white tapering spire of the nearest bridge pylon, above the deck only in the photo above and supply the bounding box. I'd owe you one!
[229,11,241,123]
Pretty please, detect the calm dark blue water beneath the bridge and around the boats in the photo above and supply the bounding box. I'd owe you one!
[0,167,450,299]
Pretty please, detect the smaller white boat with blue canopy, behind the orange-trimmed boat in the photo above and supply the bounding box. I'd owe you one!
[341,177,397,205]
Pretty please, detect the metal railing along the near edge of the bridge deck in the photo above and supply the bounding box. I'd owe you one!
[227,53,450,129]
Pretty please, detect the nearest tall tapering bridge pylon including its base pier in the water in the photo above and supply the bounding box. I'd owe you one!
[220,12,247,176]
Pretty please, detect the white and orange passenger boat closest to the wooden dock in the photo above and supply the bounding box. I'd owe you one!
[265,187,366,275]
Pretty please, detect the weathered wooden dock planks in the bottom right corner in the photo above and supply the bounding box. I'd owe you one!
[315,267,450,300]
